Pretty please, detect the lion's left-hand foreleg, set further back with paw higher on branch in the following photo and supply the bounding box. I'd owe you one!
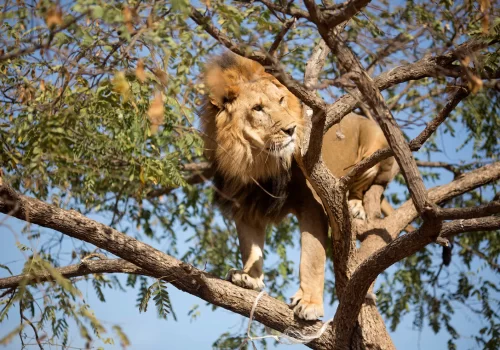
[227,221,266,290]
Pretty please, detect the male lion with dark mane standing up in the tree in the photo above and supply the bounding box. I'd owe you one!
[200,53,395,320]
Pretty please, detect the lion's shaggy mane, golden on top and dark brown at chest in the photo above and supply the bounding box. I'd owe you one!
[199,53,303,222]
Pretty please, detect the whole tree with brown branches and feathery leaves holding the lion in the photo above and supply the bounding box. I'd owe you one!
[0,0,500,349]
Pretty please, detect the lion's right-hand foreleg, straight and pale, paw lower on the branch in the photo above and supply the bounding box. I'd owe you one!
[292,202,328,320]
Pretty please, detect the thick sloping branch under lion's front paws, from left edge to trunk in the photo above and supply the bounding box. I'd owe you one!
[0,183,333,349]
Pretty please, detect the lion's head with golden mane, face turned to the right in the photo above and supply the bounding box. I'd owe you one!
[201,53,303,183]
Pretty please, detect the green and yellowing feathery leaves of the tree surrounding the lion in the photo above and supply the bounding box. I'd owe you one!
[0,0,500,349]
